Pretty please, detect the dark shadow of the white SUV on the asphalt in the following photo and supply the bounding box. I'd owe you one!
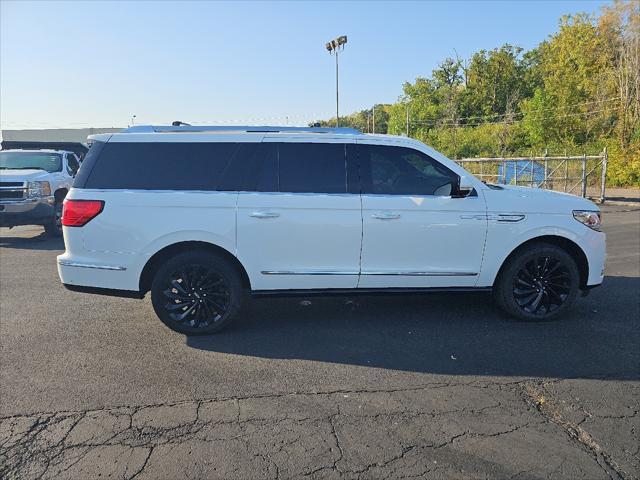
[186,277,640,380]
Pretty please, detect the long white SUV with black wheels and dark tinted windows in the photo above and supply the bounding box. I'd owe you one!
[58,126,605,334]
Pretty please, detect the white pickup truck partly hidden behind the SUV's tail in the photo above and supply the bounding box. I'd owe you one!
[0,150,80,237]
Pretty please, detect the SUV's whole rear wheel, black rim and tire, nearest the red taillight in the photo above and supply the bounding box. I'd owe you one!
[151,251,245,335]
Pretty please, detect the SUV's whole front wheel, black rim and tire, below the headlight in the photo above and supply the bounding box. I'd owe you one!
[494,243,580,321]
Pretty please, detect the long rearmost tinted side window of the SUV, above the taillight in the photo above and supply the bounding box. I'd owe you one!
[81,142,238,190]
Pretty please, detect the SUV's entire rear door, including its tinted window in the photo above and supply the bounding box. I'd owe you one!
[237,139,362,290]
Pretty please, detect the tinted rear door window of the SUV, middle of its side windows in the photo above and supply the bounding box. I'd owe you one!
[278,143,347,193]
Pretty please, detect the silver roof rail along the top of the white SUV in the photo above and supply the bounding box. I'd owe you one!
[122,124,362,135]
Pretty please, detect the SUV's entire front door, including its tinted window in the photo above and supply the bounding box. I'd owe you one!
[357,141,487,288]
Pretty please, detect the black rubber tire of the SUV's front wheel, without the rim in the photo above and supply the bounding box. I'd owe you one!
[496,244,580,322]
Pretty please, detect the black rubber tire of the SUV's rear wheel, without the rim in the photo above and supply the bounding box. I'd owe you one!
[151,251,244,335]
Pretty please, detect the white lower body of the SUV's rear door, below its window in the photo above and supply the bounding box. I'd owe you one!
[237,193,362,290]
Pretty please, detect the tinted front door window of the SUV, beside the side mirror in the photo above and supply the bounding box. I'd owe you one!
[360,145,457,196]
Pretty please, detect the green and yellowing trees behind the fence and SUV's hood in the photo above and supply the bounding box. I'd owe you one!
[315,0,640,186]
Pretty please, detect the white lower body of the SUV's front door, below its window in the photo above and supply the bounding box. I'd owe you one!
[358,195,487,288]
